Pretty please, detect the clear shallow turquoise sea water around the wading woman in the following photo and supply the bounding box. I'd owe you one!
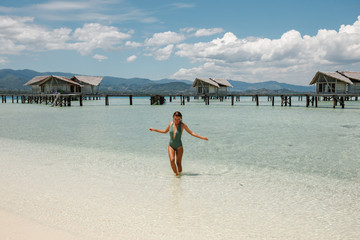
[0,98,360,240]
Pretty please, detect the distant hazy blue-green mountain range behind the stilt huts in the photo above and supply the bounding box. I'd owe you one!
[0,69,313,94]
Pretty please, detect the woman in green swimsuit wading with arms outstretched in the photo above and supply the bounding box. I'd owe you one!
[149,112,208,176]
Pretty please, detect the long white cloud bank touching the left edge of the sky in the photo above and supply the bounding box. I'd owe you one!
[0,16,133,55]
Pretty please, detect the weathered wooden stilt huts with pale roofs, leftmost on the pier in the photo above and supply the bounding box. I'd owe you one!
[24,75,103,94]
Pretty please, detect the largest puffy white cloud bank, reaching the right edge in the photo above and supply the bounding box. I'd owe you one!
[173,17,360,84]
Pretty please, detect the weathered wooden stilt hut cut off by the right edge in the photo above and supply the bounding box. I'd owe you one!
[310,71,360,94]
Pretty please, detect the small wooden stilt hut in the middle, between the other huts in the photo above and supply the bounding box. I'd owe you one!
[192,78,233,96]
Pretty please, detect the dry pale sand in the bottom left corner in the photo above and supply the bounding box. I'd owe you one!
[0,209,82,240]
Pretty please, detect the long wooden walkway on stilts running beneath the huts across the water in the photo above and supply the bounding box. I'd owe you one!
[0,93,360,108]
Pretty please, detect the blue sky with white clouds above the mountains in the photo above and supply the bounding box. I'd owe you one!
[0,0,360,85]
